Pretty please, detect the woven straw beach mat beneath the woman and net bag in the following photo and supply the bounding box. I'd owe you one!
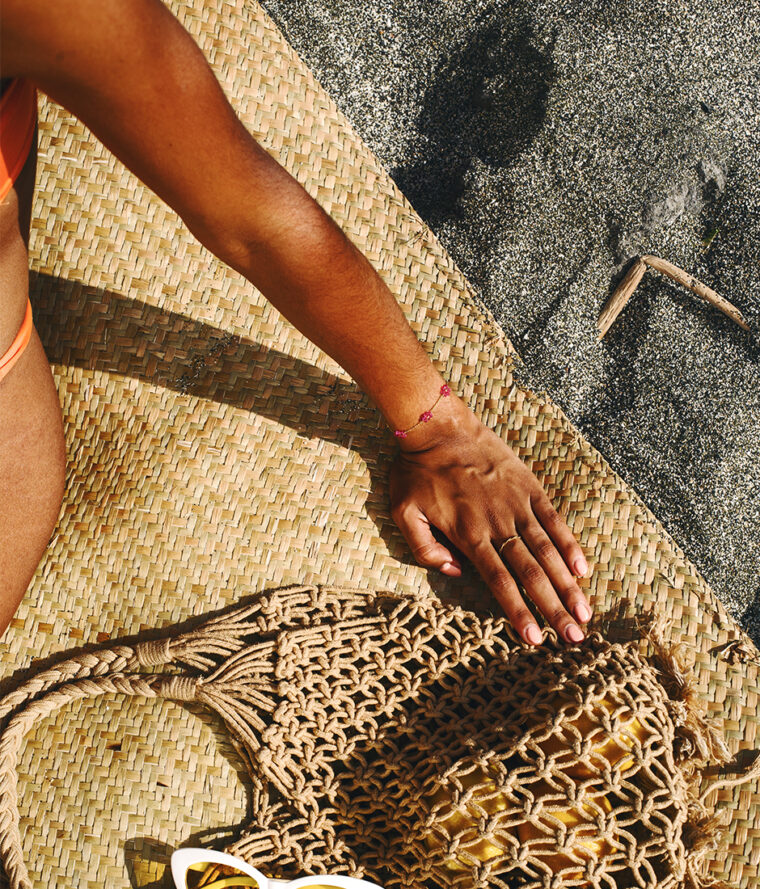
[0,0,760,889]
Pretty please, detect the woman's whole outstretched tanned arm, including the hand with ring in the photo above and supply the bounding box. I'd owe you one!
[0,0,588,640]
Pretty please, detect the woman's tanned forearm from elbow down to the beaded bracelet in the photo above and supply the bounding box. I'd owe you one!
[214,159,443,438]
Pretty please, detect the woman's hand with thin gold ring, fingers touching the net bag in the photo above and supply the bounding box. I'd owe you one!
[391,397,591,644]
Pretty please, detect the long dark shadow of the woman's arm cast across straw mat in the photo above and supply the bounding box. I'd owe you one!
[30,272,466,604]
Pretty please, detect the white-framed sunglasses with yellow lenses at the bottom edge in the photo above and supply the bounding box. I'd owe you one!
[172,849,382,889]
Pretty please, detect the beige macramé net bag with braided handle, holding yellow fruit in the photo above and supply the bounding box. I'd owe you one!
[0,587,752,889]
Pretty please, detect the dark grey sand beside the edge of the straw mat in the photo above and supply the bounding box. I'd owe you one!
[264,0,760,642]
